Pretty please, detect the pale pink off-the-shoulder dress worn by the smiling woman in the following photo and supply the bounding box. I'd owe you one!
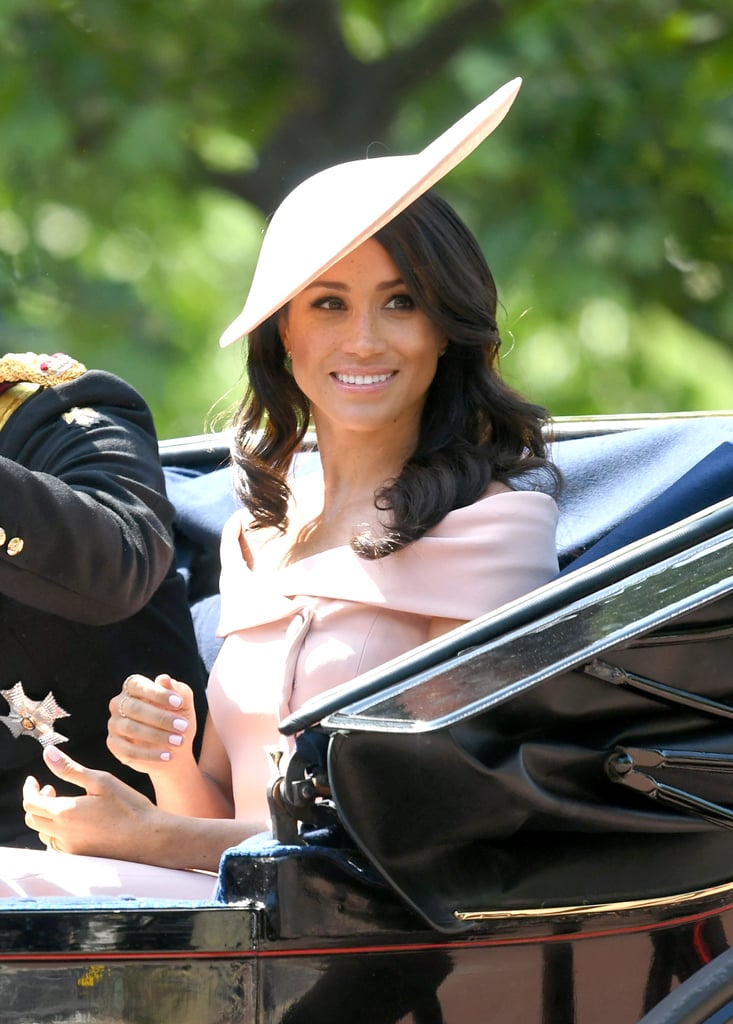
[0,490,558,898]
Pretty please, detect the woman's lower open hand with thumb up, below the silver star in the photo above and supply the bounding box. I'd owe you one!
[23,746,157,861]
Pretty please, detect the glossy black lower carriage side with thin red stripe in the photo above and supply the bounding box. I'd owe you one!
[0,864,733,1024]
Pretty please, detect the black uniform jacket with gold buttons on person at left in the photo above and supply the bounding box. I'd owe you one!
[0,371,205,846]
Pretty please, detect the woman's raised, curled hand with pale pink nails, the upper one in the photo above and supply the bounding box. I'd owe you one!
[106,675,197,775]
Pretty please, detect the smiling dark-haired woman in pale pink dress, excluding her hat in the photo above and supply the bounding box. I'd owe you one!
[12,79,557,895]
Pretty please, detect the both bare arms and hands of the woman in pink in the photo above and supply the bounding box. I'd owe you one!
[24,676,276,870]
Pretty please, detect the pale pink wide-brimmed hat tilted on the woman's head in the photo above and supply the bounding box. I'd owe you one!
[219,78,522,348]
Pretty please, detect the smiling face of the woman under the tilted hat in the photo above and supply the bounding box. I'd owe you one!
[278,239,446,446]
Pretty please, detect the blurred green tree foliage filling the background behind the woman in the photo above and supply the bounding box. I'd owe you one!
[0,0,733,436]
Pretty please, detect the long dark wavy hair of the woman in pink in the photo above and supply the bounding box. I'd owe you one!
[232,191,560,558]
